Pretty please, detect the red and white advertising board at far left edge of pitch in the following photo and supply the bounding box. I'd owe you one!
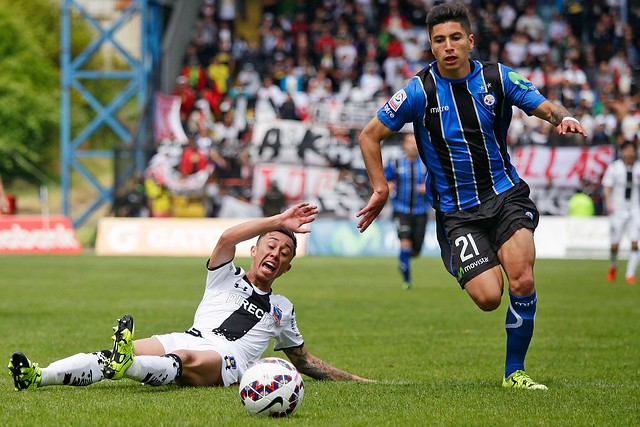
[0,216,82,254]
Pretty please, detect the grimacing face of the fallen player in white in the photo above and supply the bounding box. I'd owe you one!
[251,231,293,283]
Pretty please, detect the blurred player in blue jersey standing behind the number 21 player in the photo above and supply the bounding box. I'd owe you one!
[384,133,429,290]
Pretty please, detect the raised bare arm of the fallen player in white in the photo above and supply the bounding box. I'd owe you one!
[209,202,318,268]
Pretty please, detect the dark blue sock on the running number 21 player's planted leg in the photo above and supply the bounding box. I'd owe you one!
[504,291,537,378]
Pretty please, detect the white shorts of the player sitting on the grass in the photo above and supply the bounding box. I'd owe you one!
[153,332,250,387]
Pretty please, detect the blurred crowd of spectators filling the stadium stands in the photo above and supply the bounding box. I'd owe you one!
[119,0,640,216]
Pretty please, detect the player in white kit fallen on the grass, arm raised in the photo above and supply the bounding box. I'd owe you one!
[8,203,369,390]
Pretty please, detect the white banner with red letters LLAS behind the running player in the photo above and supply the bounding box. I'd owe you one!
[511,145,615,188]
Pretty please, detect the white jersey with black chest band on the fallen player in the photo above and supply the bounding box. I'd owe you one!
[192,261,304,362]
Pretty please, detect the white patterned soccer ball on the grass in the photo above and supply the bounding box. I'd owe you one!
[239,357,304,417]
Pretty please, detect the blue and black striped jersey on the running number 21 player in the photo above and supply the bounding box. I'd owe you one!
[378,61,545,212]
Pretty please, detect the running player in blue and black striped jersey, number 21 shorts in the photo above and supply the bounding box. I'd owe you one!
[357,3,586,390]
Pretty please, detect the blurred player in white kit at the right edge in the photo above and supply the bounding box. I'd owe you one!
[602,141,640,285]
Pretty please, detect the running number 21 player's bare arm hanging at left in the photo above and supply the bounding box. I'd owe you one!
[356,117,394,233]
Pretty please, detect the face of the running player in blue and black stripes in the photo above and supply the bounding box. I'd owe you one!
[430,21,474,79]
